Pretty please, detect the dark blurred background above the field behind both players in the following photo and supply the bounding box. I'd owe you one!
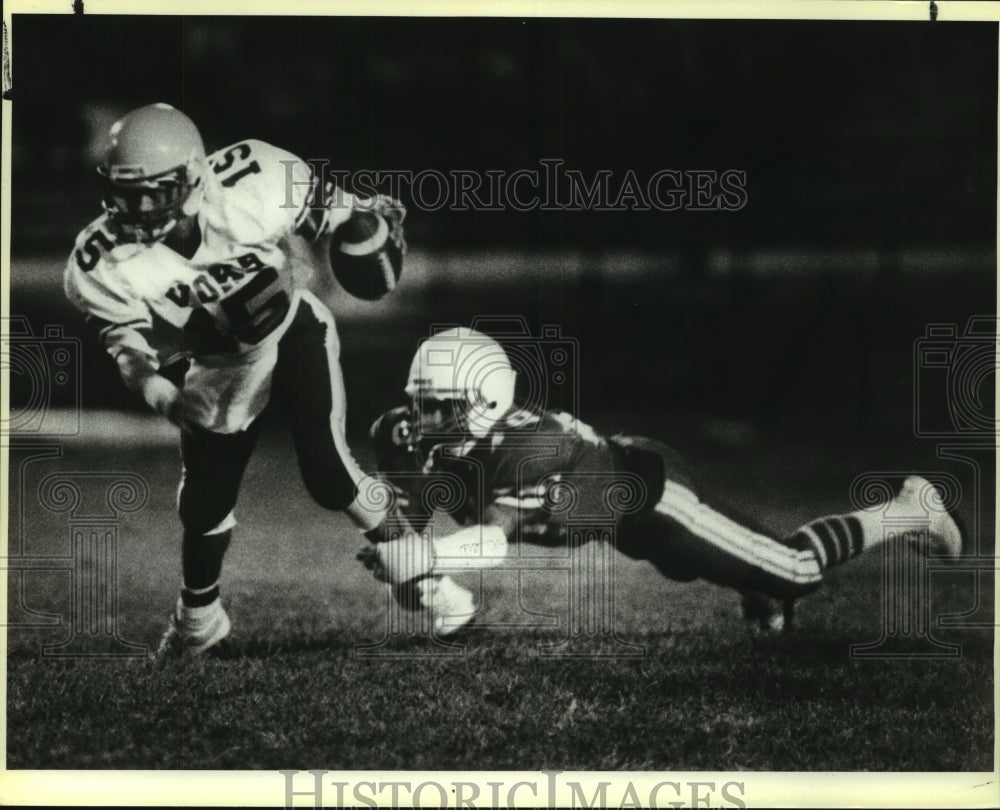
[11,15,997,444]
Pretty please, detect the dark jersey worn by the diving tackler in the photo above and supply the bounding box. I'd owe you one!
[372,408,688,545]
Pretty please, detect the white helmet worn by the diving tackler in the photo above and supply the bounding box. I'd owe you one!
[406,327,517,437]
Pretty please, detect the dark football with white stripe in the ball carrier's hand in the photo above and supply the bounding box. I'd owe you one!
[330,210,403,301]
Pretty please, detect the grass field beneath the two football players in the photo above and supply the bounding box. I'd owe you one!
[7,416,994,771]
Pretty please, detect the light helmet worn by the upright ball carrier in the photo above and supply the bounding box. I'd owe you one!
[97,104,208,244]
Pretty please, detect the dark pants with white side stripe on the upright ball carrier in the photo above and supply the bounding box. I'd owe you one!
[178,299,381,588]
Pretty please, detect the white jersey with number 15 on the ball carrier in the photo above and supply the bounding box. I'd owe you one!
[65,140,350,433]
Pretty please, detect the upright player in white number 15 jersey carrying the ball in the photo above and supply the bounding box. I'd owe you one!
[65,104,405,656]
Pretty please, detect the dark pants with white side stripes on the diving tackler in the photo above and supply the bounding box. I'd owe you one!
[618,438,823,599]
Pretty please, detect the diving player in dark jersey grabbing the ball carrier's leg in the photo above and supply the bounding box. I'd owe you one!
[358,329,963,636]
